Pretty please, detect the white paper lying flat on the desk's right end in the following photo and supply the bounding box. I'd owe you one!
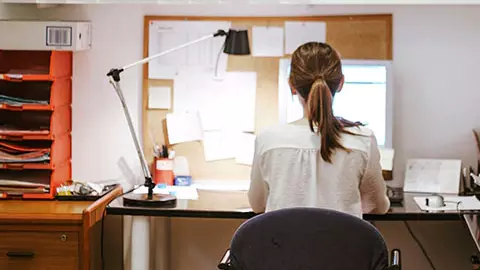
[413,196,480,211]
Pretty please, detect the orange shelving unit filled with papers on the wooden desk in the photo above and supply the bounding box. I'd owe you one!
[0,50,72,199]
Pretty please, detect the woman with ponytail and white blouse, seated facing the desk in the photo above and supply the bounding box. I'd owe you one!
[248,42,390,218]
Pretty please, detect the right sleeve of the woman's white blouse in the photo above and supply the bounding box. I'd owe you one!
[360,135,390,214]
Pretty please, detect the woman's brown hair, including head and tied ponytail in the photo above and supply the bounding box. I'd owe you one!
[289,42,361,162]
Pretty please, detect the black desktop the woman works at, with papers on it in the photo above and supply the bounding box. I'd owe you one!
[107,190,478,221]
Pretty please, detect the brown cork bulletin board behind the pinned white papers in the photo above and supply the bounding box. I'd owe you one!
[142,14,392,180]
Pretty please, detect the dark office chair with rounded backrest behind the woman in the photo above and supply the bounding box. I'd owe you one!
[218,208,401,270]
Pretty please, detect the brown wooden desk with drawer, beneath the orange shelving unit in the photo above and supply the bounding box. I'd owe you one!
[0,186,122,270]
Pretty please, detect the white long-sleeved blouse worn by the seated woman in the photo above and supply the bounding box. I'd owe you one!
[248,119,390,218]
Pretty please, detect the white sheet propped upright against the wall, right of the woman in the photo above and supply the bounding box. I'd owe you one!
[403,159,462,194]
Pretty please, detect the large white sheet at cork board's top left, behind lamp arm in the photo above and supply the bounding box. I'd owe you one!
[148,21,231,79]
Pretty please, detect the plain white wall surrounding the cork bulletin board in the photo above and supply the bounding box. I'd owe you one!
[0,2,480,270]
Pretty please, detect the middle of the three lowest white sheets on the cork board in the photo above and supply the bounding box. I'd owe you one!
[203,131,237,161]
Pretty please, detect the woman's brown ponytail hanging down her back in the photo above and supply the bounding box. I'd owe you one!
[307,78,348,163]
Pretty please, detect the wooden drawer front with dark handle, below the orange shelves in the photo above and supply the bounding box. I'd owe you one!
[0,231,79,270]
